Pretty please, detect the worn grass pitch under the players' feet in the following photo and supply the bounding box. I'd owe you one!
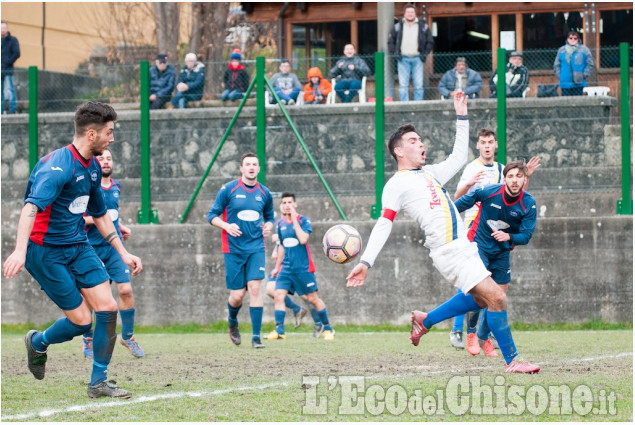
[1,326,633,422]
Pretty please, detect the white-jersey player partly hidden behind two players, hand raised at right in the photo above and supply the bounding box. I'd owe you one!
[450,128,540,350]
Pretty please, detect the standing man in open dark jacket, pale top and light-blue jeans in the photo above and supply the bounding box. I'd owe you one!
[388,4,434,102]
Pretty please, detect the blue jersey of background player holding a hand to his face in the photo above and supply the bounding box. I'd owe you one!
[276,214,315,273]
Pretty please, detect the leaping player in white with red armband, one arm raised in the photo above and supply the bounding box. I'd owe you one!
[346,92,540,373]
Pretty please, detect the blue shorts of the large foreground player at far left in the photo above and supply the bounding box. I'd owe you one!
[25,241,108,310]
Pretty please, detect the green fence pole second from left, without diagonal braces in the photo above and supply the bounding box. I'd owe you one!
[137,61,159,224]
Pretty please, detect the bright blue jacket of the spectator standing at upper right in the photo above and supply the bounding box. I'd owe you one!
[553,42,593,89]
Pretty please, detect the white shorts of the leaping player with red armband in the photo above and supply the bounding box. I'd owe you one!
[430,237,491,294]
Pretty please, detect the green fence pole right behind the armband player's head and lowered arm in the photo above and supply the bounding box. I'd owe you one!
[370,52,384,220]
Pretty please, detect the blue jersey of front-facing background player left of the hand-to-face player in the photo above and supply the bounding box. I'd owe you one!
[207,179,273,254]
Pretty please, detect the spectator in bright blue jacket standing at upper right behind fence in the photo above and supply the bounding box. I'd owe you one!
[553,31,593,96]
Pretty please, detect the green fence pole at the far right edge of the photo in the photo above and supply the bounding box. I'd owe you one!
[617,43,633,215]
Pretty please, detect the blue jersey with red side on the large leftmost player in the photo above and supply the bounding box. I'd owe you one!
[24,145,107,246]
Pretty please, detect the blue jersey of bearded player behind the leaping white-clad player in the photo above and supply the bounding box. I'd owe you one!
[454,184,536,255]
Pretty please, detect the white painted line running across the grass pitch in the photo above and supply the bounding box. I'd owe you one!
[0,352,633,421]
